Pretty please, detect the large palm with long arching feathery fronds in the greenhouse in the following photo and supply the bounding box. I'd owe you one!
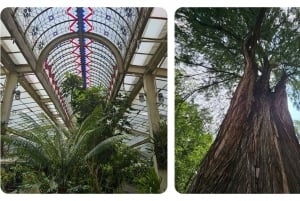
[2,109,124,193]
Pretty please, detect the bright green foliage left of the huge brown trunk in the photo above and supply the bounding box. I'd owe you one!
[175,71,213,193]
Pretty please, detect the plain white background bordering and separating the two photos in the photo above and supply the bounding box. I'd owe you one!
[0,0,300,201]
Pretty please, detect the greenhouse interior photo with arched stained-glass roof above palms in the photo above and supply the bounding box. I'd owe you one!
[0,7,168,193]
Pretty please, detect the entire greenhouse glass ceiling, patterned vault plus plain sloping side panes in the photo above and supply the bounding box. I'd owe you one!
[1,7,168,154]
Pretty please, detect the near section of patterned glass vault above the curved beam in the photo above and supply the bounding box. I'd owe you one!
[14,7,139,57]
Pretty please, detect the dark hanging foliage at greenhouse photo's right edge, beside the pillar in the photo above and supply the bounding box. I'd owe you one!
[152,121,168,170]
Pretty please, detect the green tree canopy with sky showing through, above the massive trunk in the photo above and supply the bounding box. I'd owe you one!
[175,8,300,109]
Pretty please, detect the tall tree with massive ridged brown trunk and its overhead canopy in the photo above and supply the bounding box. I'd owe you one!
[176,8,300,193]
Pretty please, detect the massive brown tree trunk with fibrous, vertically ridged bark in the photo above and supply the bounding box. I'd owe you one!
[188,11,300,193]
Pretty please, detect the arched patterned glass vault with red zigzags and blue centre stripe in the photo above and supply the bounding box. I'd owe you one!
[10,7,139,112]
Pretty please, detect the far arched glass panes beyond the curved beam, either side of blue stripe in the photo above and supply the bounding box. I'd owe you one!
[44,38,117,88]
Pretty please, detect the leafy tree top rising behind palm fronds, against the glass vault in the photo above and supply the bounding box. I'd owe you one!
[62,74,130,128]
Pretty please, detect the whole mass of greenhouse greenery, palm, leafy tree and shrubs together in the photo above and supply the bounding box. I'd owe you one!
[2,74,159,193]
